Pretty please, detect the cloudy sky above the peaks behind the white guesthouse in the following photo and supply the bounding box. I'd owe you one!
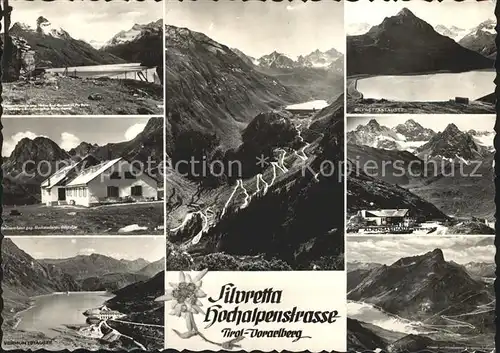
[2,117,149,156]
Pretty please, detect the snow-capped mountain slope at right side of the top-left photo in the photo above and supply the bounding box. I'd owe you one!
[100,19,164,80]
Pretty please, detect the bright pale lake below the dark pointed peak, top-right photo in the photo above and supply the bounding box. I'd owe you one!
[357,71,496,102]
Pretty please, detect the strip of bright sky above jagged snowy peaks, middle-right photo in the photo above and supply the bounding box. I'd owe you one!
[346,114,495,132]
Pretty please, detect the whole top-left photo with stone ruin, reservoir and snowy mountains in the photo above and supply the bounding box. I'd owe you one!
[0,0,164,116]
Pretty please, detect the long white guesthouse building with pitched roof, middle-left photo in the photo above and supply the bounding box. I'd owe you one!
[41,156,158,207]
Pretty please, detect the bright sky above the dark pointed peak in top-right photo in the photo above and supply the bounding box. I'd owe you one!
[345,0,495,29]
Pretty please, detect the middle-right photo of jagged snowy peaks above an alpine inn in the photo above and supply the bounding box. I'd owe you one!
[346,114,495,235]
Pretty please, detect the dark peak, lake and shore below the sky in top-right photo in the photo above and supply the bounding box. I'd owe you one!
[346,8,496,114]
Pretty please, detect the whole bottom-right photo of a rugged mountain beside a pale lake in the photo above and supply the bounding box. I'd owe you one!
[346,236,496,353]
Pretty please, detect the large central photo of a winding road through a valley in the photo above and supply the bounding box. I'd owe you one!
[165,1,345,271]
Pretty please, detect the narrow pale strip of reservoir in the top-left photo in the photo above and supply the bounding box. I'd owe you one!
[46,63,159,83]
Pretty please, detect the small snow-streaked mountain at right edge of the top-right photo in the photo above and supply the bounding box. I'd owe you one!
[458,20,497,60]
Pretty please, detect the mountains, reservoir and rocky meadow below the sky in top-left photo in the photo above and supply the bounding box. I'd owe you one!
[3,5,163,115]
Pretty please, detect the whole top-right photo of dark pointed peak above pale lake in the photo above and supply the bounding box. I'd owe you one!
[345,0,497,114]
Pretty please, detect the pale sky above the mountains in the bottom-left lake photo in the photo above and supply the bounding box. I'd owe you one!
[11,236,165,262]
